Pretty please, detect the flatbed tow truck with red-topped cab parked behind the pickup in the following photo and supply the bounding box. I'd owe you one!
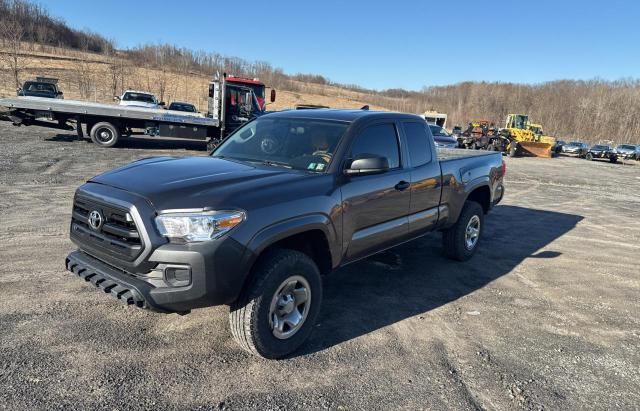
[0,74,276,148]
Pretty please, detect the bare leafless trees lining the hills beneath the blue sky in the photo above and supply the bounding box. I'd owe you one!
[0,0,640,143]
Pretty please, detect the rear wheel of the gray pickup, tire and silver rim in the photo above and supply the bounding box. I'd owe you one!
[442,201,484,261]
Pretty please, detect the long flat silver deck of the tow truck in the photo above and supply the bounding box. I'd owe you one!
[0,97,219,127]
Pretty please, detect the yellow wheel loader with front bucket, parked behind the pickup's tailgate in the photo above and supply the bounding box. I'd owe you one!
[500,114,556,158]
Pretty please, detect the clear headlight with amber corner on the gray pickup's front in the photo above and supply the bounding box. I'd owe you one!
[156,211,245,242]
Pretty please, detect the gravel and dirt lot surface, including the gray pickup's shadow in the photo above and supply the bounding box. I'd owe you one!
[0,124,640,410]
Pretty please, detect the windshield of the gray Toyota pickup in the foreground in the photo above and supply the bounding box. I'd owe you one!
[211,118,349,172]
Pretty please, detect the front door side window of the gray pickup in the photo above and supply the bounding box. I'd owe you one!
[351,124,400,168]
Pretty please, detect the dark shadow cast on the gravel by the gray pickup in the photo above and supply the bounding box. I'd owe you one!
[294,205,583,356]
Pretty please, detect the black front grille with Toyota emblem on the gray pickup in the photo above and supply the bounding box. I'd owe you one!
[71,197,144,261]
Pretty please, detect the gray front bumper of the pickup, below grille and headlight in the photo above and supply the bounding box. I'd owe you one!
[66,233,252,313]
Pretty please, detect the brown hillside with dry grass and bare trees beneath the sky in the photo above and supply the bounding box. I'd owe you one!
[0,0,640,143]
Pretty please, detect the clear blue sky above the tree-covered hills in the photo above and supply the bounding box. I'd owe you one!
[38,0,640,90]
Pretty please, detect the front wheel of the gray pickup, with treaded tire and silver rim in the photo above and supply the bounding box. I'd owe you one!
[229,249,322,359]
